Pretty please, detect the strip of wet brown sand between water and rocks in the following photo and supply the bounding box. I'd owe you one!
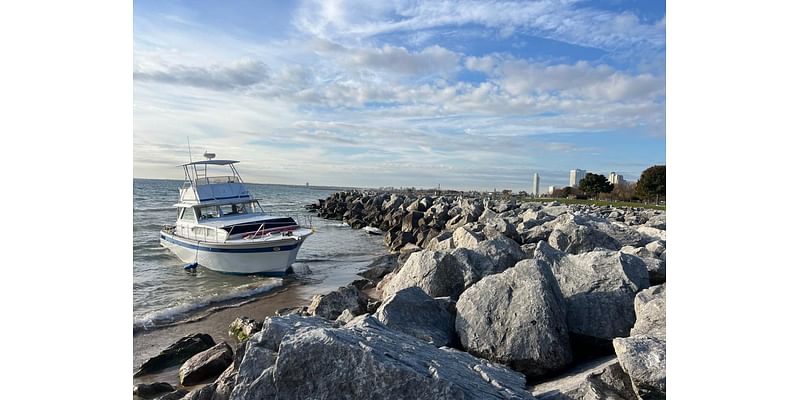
[131,261,380,390]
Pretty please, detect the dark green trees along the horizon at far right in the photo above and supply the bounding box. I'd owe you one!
[553,165,667,202]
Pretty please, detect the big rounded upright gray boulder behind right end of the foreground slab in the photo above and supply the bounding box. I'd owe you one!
[456,260,572,377]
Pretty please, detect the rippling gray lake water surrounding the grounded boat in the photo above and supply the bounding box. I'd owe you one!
[133,179,386,333]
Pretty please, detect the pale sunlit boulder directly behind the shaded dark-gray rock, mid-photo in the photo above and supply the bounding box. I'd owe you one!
[383,250,475,299]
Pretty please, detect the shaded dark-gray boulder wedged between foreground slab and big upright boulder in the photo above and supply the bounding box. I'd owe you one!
[375,287,457,347]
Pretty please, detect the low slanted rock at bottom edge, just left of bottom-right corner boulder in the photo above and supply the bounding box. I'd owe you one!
[532,357,636,400]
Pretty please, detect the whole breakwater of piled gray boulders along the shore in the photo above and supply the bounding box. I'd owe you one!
[133,192,666,399]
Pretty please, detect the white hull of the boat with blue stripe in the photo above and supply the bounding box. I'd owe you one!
[160,231,305,276]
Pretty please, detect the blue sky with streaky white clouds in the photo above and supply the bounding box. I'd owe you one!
[133,0,666,192]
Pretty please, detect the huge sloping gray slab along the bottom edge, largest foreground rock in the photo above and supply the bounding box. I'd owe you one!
[231,315,533,400]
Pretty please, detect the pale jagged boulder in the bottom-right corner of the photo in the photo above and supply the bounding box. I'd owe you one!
[613,335,667,400]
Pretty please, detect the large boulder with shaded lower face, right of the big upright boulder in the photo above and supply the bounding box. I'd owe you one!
[533,242,649,340]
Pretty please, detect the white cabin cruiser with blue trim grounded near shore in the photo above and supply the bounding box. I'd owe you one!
[161,154,312,276]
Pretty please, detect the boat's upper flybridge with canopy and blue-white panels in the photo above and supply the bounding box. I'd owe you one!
[180,158,252,204]
